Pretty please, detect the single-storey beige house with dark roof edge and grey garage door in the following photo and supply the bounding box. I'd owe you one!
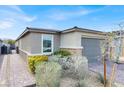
[16,26,105,61]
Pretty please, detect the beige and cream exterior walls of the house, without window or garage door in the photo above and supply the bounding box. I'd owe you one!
[16,28,103,55]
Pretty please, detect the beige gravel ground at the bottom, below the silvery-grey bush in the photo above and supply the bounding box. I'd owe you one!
[60,71,103,87]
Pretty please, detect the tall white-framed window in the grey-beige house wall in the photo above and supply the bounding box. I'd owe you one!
[42,34,53,54]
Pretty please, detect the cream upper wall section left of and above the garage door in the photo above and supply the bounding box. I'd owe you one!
[60,32,104,48]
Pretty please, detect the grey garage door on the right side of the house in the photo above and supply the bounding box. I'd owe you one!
[81,38,102,62]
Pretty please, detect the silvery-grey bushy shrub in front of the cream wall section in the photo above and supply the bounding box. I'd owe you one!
[59,56,88,79]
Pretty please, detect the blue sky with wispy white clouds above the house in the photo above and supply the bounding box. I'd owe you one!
[0,5,124,39]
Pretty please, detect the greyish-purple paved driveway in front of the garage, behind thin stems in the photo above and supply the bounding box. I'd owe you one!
[89,62,124,84]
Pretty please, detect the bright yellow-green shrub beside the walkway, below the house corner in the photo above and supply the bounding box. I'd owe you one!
[28,56,48,73]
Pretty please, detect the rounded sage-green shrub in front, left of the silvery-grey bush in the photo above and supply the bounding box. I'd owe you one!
[35,62,61,87]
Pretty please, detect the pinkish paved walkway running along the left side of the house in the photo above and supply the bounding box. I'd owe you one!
[0,54,35,87]
